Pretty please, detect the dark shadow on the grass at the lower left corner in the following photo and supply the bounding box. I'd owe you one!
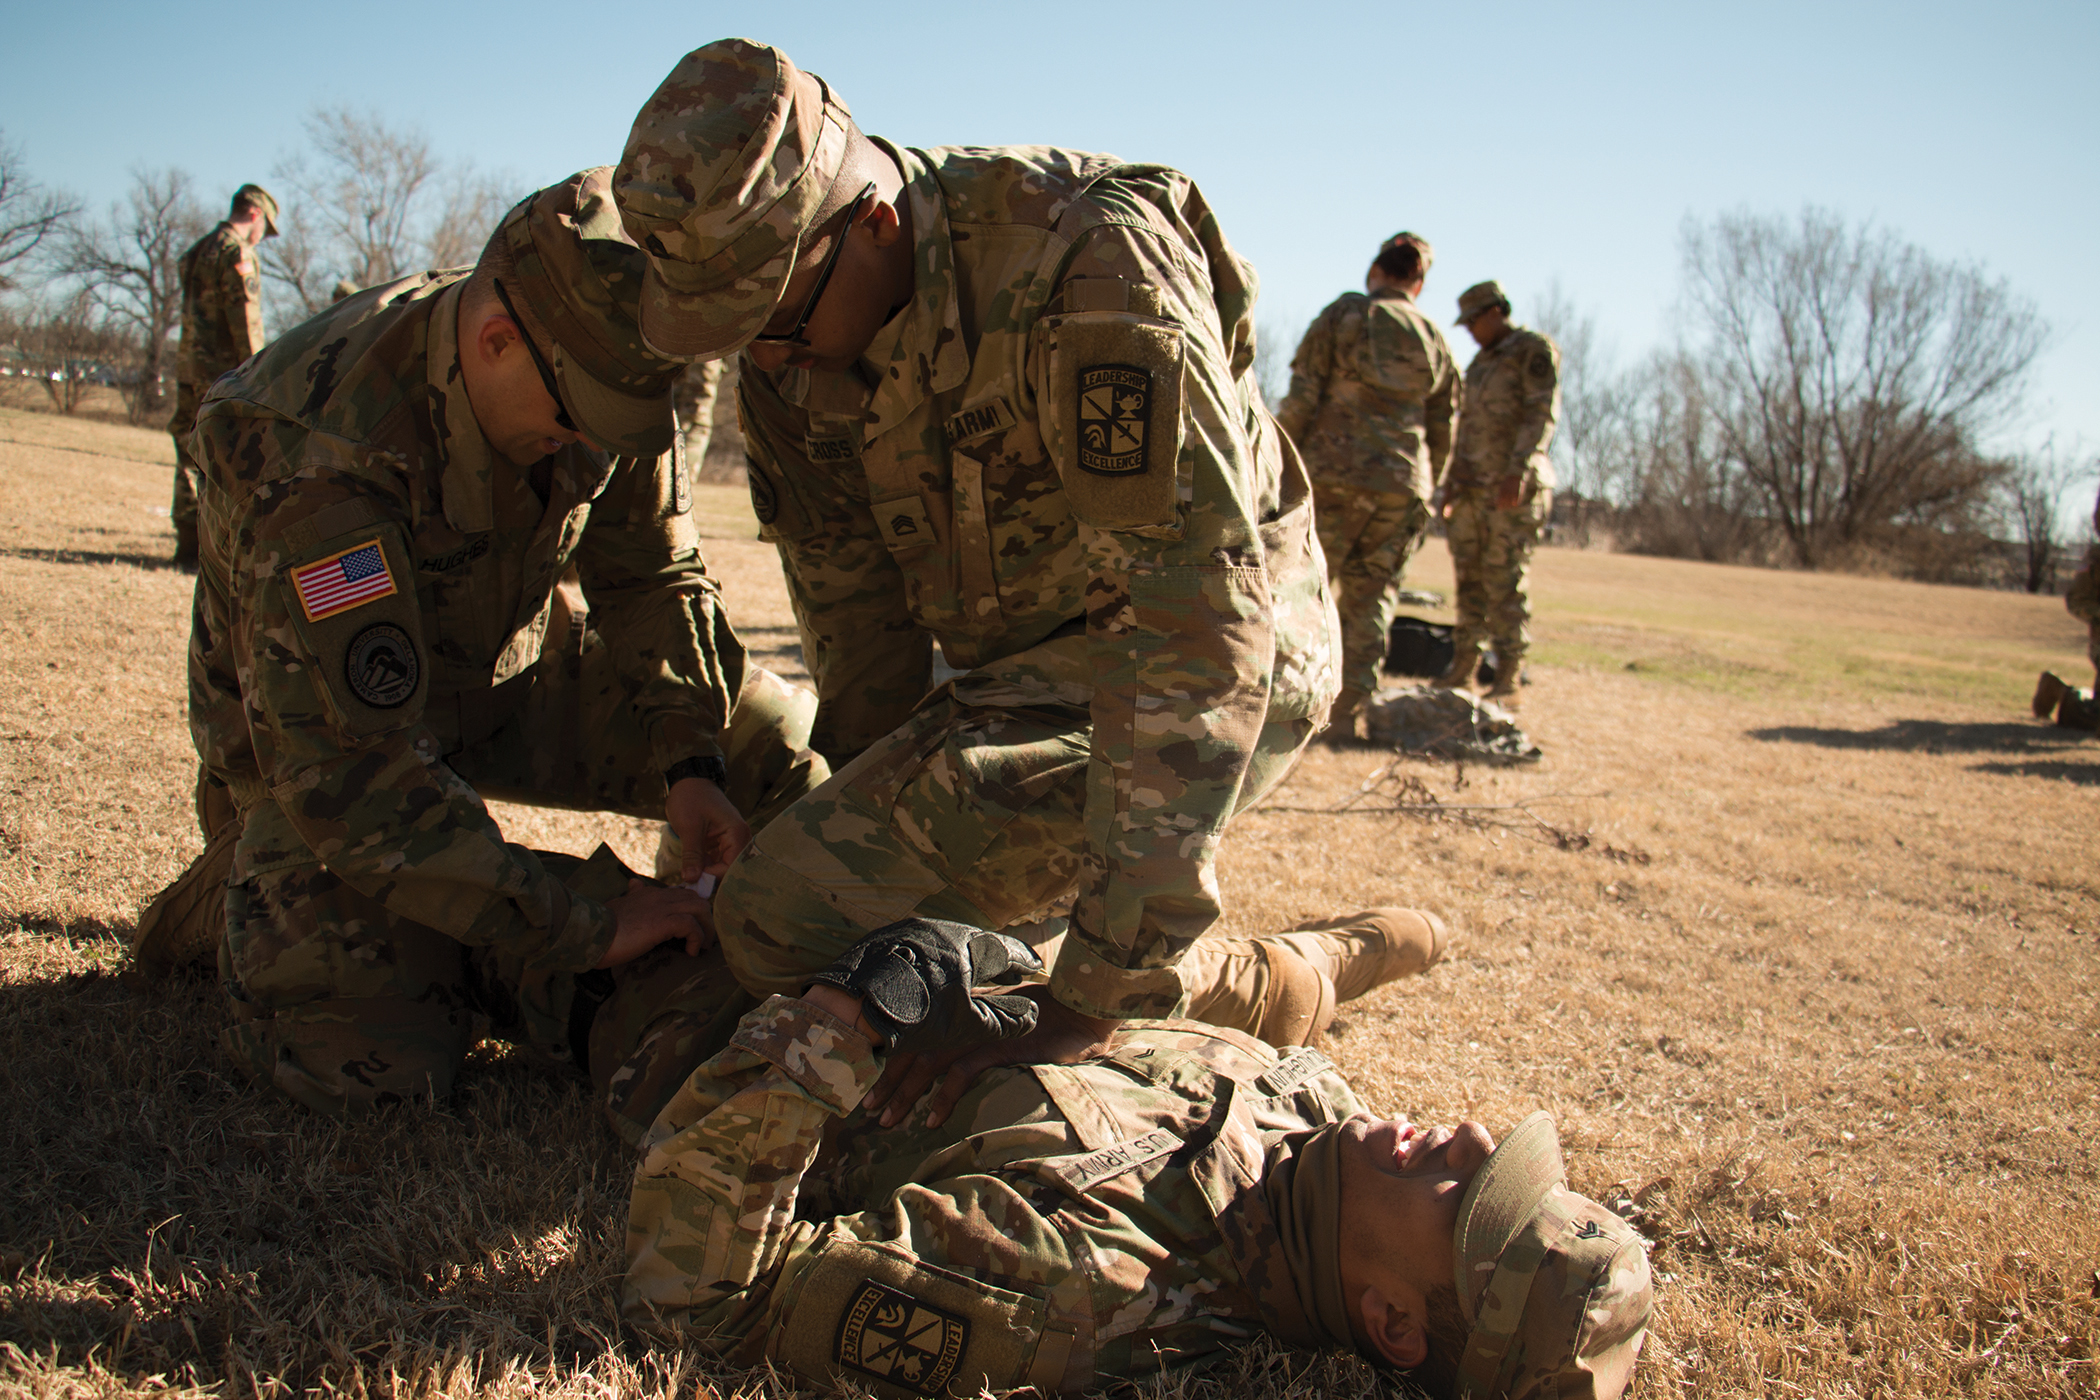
[0,948,632,1396]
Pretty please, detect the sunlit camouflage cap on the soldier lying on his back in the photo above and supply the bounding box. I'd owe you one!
[1451,1112,1655,1400]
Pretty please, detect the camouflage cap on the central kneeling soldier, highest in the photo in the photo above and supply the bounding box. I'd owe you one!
[613,40,853,359]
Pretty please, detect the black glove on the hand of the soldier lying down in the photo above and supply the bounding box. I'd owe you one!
[811,919,1044,1052]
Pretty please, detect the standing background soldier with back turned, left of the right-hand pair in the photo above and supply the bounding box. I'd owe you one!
[1277,233,1460,737]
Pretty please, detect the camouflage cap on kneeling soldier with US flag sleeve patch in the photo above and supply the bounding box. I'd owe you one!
[491,166,683,458]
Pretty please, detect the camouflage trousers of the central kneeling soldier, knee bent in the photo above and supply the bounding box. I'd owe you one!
[714,642,1313,1003]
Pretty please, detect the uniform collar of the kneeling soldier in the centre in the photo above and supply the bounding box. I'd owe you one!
[781,136,970,439]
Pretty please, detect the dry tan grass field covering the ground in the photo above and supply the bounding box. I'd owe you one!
[0,398,2100,1400]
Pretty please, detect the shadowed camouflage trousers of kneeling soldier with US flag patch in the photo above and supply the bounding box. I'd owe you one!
[218,634,830,1138]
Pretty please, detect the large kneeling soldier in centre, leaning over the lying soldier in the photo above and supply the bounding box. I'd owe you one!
[615,40,1336,1125]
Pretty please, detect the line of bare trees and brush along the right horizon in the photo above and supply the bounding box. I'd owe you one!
[1535,208,2094,592]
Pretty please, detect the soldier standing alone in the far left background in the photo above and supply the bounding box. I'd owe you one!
[168,185,277,569]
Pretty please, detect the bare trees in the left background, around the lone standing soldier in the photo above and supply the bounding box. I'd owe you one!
[0,117,508,424]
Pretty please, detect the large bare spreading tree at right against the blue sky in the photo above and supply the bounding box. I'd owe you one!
[1682,208,2048,569]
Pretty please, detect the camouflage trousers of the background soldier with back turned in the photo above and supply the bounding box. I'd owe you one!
[1313,481,1430,695]
